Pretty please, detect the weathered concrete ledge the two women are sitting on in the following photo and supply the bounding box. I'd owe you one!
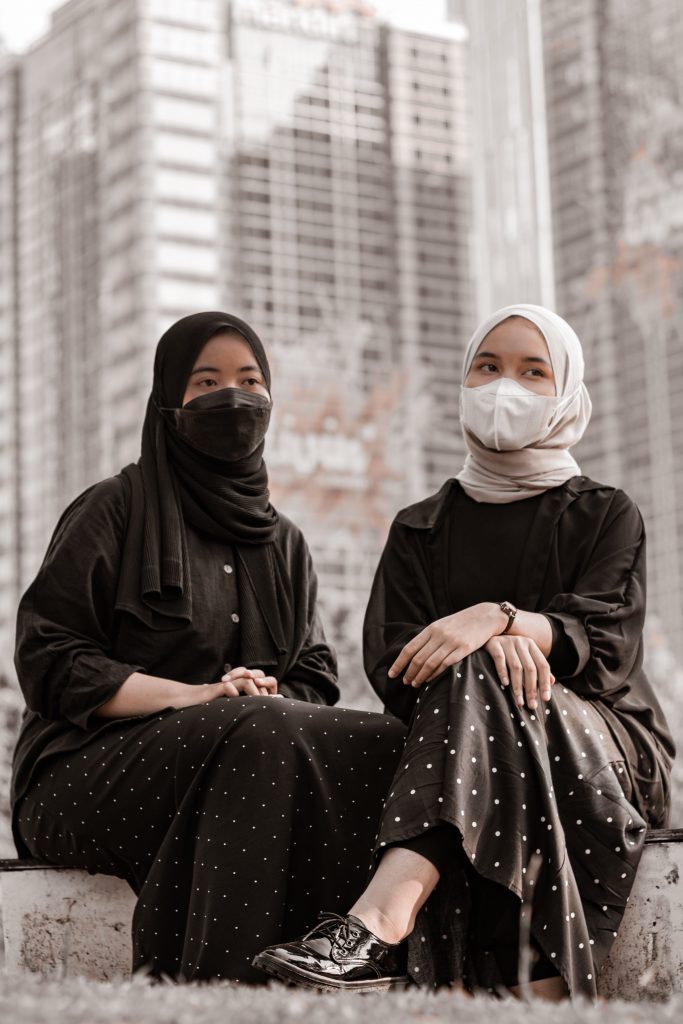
[0,829,683,999]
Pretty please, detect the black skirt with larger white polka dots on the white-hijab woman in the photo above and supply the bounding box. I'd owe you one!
[376,651,666,996]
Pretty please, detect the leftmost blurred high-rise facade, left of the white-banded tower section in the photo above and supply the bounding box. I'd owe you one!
[15,0,109,598]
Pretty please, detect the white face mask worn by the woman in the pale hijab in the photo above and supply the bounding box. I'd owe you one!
[460,377,563,452]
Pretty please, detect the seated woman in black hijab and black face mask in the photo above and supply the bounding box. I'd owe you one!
[11,312,404,981]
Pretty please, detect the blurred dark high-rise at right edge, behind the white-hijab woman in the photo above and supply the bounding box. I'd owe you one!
[541,0,683,660]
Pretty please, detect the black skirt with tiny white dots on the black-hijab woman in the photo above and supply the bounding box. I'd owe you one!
[15,697,405,983]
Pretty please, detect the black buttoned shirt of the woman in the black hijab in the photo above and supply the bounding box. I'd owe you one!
[11,477,339,806]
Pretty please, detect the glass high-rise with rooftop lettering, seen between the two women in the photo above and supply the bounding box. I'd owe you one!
[227,4,471,678]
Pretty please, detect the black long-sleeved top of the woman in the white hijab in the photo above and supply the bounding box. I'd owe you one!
[364,476,675,758]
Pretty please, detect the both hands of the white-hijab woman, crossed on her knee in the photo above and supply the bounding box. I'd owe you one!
[389,602,555,710]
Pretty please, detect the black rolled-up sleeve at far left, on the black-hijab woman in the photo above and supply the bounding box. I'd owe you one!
[14,477,144,729]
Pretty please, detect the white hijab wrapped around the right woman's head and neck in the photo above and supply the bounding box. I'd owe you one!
[457,303,592,504]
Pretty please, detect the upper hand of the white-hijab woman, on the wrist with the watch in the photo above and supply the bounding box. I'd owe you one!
[389,601,502,686]
